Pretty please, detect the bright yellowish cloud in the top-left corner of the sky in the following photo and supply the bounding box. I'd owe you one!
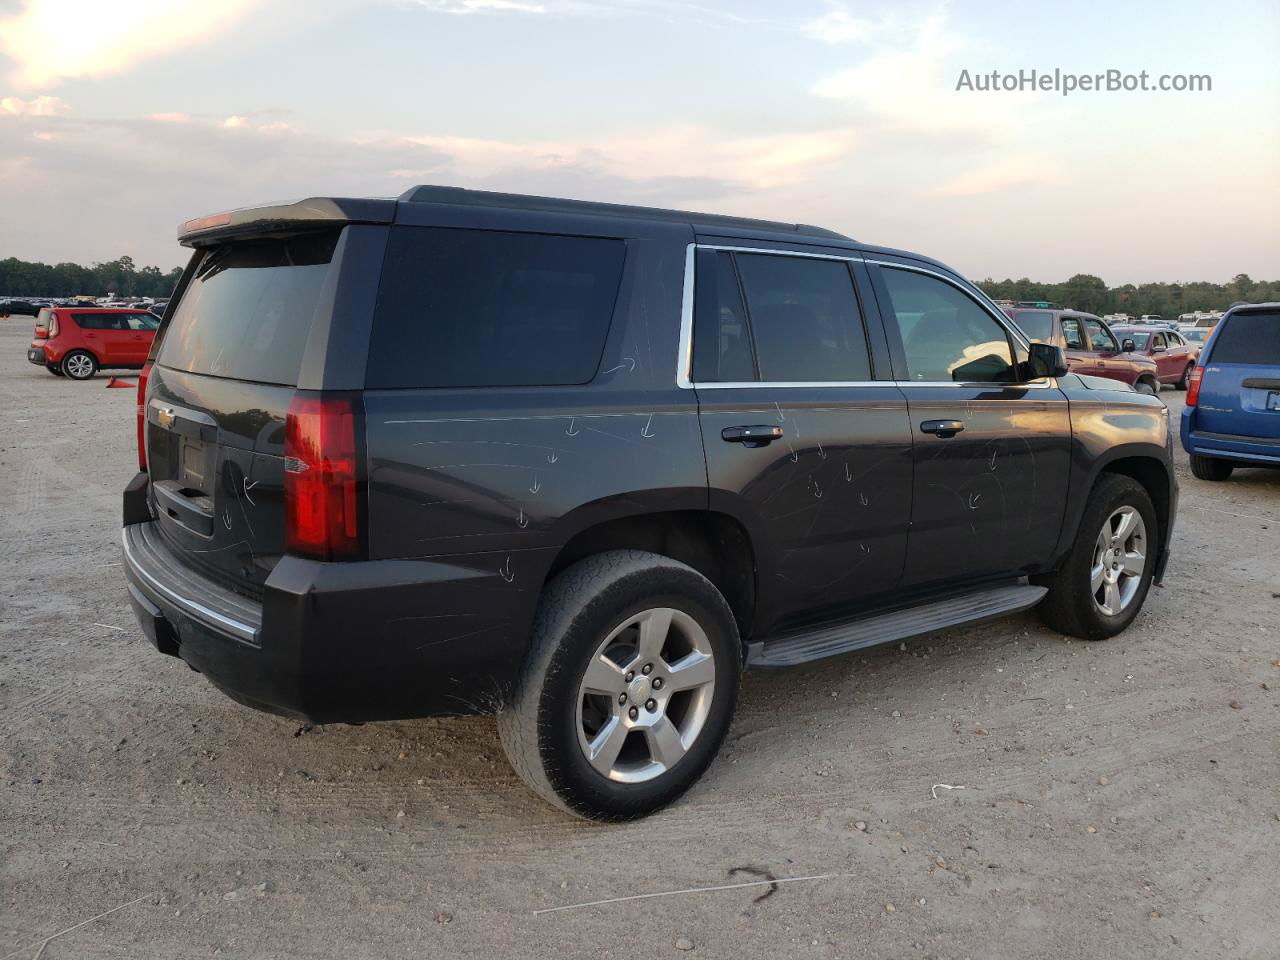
[0,0,262,88]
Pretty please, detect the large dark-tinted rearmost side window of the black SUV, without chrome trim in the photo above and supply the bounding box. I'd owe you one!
[366,227,626,388]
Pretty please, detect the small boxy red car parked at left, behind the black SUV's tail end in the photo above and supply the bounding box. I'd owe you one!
[27,307,160,380]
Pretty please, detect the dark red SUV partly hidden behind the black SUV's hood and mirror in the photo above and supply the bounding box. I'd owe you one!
[1005,307,1172,394]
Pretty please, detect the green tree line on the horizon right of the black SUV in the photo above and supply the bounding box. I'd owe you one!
[978,274,1280,320]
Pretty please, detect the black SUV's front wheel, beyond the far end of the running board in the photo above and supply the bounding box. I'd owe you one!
[1037,474,1160,640]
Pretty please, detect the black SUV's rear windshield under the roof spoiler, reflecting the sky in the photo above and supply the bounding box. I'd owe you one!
[157,230,338,387]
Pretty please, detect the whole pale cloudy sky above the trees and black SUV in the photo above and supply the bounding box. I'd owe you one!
[0,0,1280,285]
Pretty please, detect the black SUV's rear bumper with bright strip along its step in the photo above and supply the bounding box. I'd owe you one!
[122,475,552,723]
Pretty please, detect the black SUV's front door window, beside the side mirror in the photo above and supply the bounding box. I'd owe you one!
[881,268,1008,383]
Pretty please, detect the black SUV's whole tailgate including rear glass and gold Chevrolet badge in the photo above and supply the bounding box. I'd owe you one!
[146,230,338,596]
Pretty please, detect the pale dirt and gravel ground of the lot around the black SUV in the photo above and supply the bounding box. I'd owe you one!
[0,317,1280,960]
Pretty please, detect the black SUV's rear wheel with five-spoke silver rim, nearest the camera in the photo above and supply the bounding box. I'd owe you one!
[498,550,742,820]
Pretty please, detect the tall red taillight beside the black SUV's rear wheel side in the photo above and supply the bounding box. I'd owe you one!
[284,393,360,561]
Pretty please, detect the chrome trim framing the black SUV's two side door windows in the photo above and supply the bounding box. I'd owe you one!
[676,242,1056,390]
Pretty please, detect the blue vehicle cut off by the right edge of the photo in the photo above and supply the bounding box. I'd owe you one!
[1181,303,1280,480]
